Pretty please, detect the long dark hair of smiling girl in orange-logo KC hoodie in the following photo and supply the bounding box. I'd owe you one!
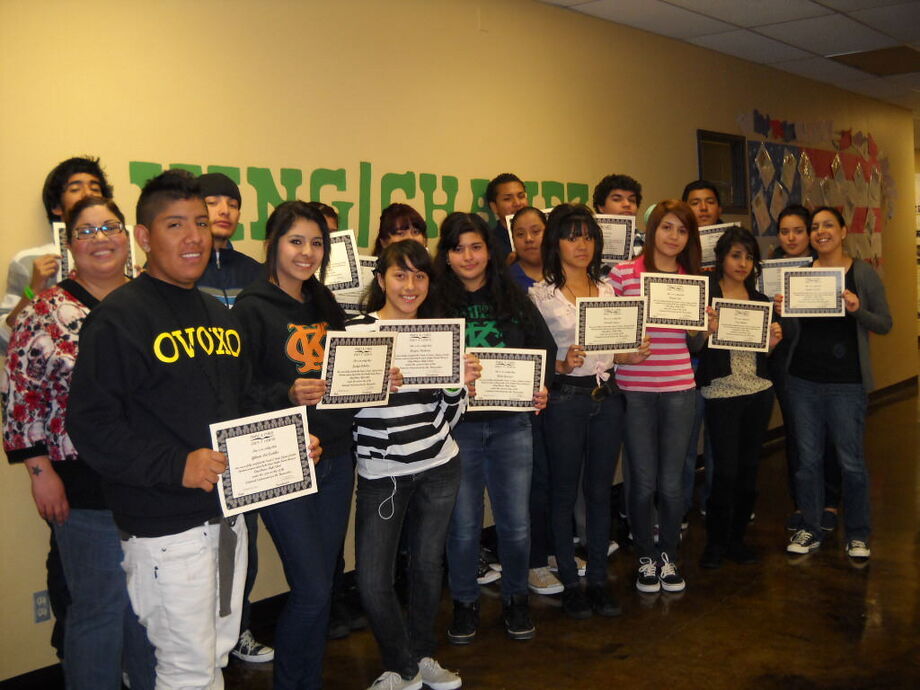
[265,201,345,330]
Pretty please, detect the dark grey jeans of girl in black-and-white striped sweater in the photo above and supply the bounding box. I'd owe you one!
[355,457,460,678]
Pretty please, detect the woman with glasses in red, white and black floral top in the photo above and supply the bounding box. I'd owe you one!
[2,197,154,690]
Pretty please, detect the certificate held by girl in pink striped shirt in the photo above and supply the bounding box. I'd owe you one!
[641,273,709,331]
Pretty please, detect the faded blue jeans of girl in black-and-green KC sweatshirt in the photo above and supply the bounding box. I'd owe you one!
[447,412,533,604]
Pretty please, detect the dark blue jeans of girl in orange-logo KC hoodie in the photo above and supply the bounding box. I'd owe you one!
[261,455,354,690]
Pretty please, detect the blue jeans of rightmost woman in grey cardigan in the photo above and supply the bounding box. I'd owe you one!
[787,376,872,541]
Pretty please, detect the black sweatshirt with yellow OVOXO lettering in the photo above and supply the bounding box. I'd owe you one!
[66,273,248,537]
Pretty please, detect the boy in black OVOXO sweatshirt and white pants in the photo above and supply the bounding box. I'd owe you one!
[67,170,319,688]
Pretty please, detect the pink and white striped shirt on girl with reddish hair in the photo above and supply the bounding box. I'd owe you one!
[610,256,696,393]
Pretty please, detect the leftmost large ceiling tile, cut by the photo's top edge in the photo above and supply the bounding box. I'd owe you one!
[573,0,736,38]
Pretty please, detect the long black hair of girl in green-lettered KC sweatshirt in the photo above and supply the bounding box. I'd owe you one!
[434,211,531,324]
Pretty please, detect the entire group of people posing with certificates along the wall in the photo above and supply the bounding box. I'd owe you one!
[0,157,892,690]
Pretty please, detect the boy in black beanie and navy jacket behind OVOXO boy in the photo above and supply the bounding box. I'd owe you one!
[198,173,262,308]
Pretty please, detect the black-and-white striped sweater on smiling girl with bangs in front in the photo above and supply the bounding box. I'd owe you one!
[345,313,466,479]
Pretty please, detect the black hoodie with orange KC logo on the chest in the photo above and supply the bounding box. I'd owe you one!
[232,279,358,457]
